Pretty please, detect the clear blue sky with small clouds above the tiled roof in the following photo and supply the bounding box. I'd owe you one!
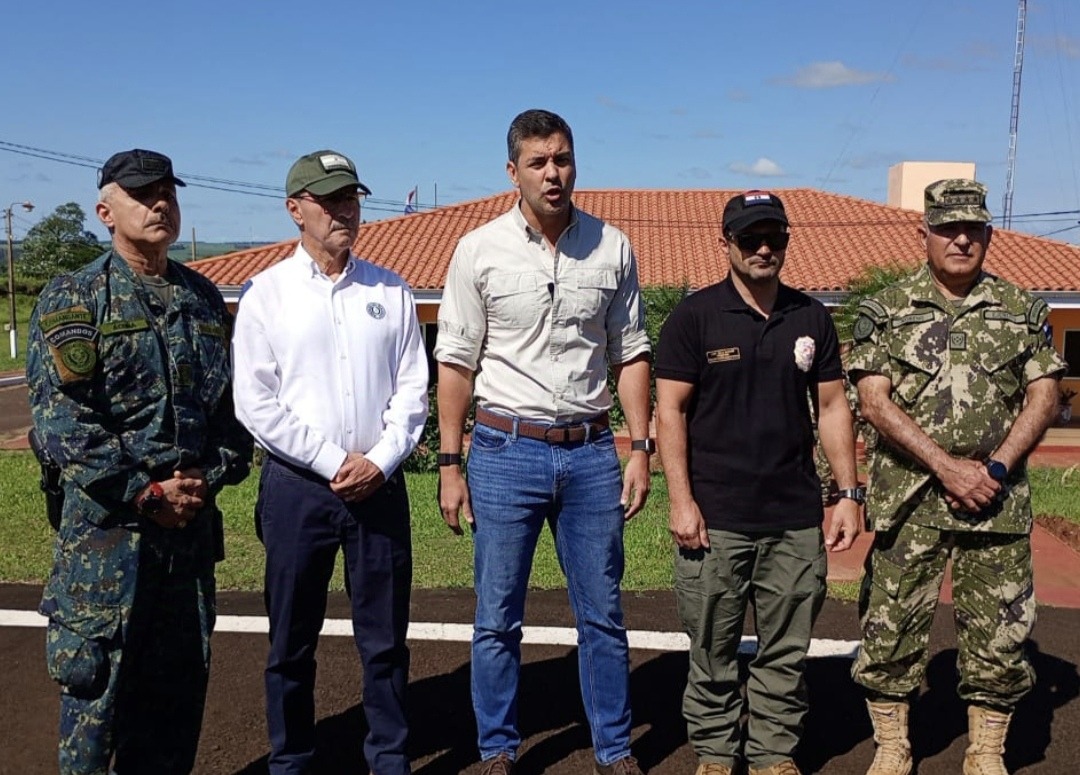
[0,0,1080,242]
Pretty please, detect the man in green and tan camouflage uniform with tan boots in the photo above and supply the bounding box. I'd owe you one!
[849,179,1065,775]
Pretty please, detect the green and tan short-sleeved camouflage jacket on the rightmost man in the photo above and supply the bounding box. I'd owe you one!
[848,267,1065,533]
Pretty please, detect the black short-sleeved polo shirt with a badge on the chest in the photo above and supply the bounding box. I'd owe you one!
[656,275,843,531]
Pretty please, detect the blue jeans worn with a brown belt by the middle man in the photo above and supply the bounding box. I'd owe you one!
[468,418,631,764]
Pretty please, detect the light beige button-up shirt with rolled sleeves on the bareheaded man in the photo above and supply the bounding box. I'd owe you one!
[435,203,649,423]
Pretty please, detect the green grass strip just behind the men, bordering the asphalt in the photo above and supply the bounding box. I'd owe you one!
[0,451,1080,599]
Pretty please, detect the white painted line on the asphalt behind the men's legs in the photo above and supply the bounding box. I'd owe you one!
[0,609,859,658]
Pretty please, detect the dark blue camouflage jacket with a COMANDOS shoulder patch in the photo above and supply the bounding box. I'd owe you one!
[26,251,252,613]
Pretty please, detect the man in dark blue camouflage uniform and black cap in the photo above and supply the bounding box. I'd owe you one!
[27,150,251,775]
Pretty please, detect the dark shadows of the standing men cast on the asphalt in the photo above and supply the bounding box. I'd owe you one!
[223,641,1080,775]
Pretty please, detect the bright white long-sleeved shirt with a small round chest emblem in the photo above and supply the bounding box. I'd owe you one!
[232,245,428,480]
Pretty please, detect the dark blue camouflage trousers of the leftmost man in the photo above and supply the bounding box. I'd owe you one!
[46,525,215,775]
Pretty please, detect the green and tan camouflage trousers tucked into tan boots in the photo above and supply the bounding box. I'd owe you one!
[851,522,1036,709]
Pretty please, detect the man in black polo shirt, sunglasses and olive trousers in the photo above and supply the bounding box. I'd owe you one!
[657,191,863,775]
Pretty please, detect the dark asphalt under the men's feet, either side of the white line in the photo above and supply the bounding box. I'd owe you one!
[0,585,1080,775]
